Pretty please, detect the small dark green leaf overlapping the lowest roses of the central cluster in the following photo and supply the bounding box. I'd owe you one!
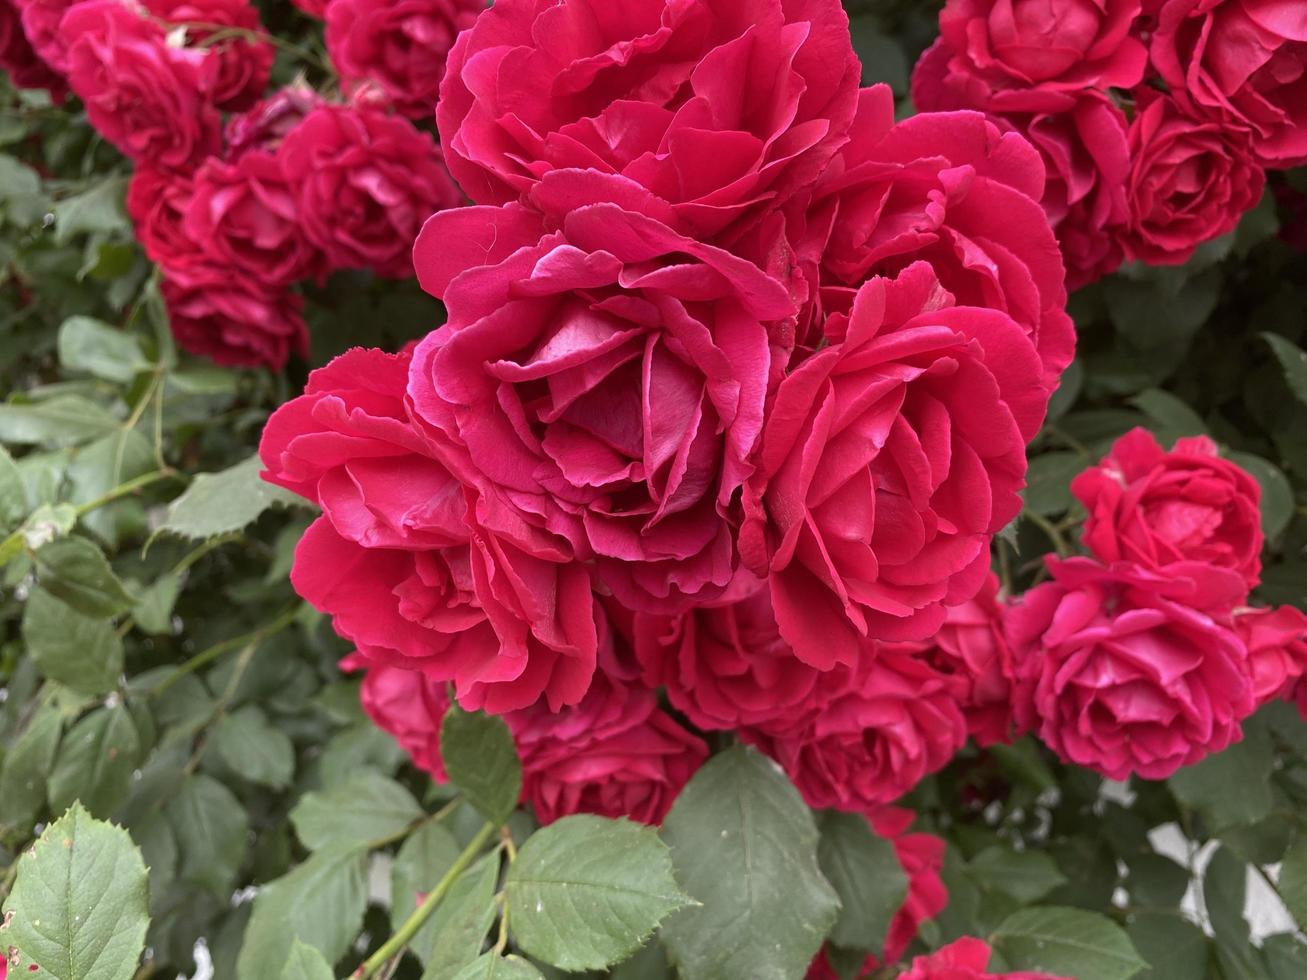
[440,704,521,826]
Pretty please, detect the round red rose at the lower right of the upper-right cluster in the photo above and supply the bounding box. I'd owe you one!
[1123,93,1266,265]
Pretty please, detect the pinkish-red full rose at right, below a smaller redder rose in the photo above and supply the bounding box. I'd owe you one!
[1006,558,1255,779]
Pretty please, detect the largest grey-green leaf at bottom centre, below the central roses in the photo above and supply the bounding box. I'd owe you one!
[663,747,839,980]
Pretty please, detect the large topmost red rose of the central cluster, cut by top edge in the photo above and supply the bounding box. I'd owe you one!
[437,0,859,240]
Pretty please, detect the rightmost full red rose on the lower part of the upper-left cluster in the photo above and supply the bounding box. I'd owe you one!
[277,106,463,278]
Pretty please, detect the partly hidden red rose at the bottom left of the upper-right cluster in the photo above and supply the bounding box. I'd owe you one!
[999,91,1131,289]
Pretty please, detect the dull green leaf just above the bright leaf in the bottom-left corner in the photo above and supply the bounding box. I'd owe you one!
[48,704,141,817]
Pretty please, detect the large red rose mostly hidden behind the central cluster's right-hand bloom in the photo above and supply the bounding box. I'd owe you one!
[784,85,1076,391]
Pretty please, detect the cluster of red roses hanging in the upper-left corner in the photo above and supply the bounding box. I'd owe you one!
[0,0,471,367]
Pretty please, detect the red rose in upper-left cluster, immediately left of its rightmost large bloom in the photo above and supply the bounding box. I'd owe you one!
[186,150,325,287]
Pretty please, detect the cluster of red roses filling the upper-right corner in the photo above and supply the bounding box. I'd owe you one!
[912,0,1307,289]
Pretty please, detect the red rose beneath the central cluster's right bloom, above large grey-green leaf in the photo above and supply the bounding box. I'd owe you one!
[741,644,967,813]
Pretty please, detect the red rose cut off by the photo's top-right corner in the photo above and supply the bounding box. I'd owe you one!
[1150,0,1307,169]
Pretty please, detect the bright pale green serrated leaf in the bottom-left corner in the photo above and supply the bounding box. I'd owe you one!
[0,805,148,980]
